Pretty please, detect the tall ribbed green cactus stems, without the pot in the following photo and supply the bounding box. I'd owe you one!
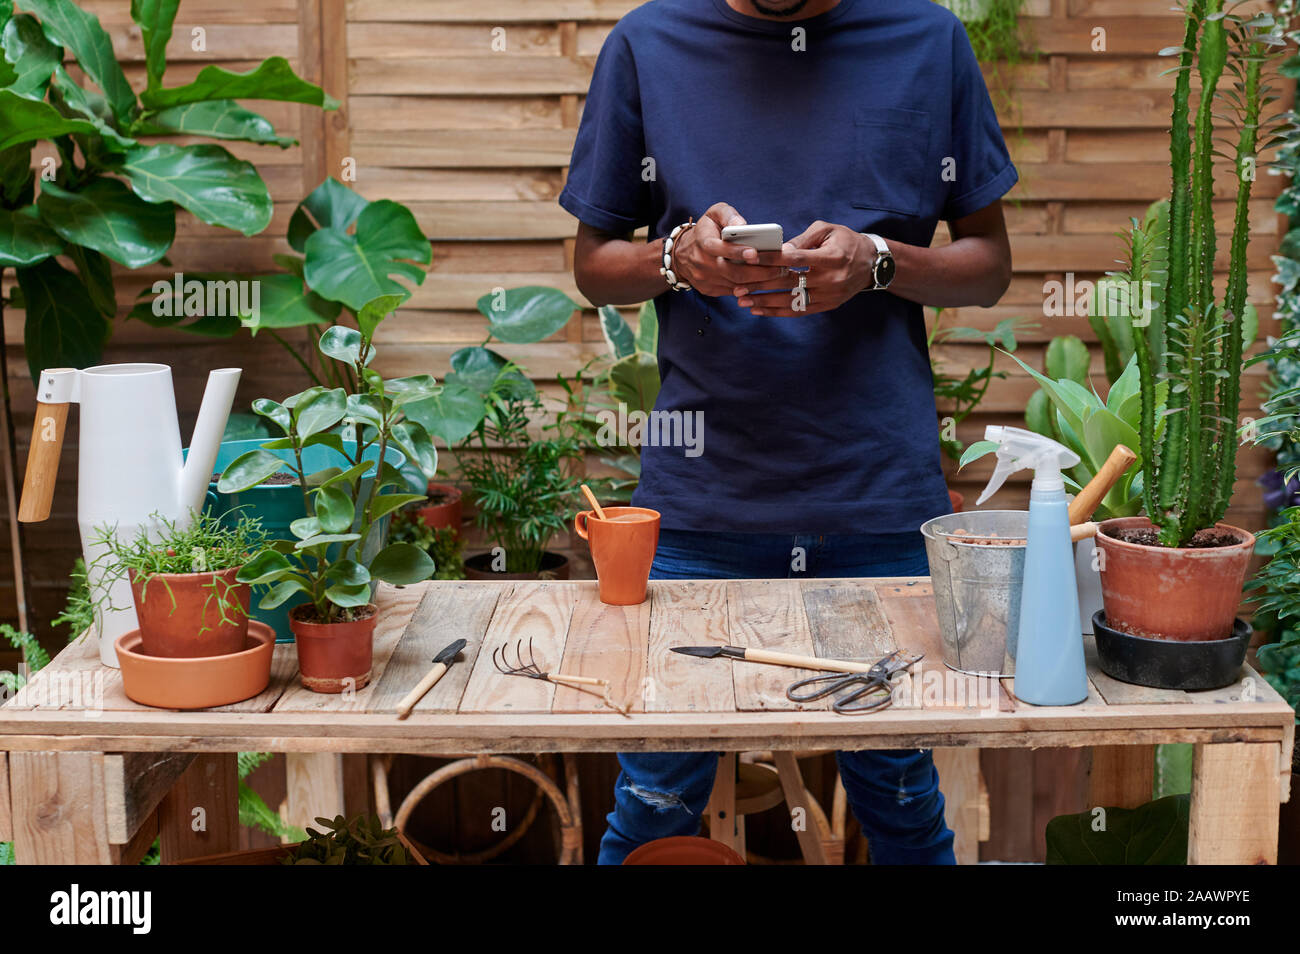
[1134,0,1283,547]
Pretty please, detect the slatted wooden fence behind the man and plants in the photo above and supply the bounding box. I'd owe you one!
[0,0,1281,859]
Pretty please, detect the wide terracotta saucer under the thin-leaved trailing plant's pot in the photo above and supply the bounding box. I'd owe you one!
[114,620,276,708]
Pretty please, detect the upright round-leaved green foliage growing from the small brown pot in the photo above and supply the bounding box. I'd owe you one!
[226,302,438,623]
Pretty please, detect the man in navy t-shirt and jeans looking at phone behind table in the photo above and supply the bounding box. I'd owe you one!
[559,0,1017,863]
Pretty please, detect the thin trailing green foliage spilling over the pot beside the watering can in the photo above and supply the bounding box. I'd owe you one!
[87,511,267,633]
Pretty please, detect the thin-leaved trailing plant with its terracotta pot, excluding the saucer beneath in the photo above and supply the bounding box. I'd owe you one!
[95,512,267,658]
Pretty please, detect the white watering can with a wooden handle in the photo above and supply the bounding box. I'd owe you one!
[18,364,239,668]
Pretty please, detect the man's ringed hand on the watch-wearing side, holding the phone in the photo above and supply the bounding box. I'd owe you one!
[731,221,876,317]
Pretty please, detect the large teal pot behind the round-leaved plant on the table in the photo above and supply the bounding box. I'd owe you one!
[208,438,408,642]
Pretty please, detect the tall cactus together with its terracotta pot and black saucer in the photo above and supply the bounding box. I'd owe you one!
[1097,0,1283,665]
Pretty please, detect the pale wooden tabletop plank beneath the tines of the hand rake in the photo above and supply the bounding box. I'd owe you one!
[460,582,577,712]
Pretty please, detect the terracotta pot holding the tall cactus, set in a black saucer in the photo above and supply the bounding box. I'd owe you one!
[1096,517,1255,641]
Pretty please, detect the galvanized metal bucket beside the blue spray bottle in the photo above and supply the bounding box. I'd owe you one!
[920,509,1030,676]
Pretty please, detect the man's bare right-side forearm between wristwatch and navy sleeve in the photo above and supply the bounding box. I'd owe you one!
[884,235,1011,308]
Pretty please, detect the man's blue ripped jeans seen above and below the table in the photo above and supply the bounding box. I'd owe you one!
[599,530,956,864]
